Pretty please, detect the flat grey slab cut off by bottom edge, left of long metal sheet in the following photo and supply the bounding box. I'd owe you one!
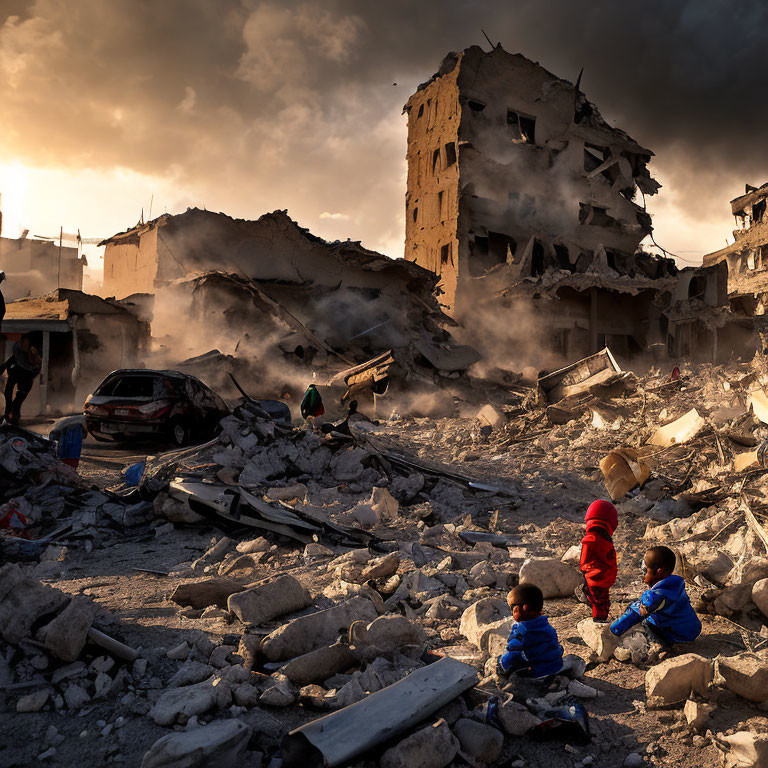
[141,720,251,768]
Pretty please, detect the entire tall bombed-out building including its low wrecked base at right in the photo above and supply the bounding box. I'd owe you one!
[404,46,751,359]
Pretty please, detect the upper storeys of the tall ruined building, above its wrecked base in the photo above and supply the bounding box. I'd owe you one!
[405,46,663,314]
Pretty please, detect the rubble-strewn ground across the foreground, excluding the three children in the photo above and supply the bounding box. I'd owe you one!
[0,353,768,768]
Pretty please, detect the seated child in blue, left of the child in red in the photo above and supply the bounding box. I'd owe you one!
[498,583,563,677]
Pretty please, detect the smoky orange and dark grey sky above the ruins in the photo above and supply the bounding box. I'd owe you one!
[0,0,768,280]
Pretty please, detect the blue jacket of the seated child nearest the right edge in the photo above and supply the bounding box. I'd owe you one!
[611,574,701,643]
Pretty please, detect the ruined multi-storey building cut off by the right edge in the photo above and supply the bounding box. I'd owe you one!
[704,182,768,316]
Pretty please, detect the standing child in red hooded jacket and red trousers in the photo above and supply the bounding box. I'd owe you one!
[579,500,619,622]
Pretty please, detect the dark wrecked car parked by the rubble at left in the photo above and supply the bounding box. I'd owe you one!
[83,369,230,446]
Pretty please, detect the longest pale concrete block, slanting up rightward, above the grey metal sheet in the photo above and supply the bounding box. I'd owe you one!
[261,597,378,661]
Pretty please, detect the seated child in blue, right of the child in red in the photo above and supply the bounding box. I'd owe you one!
[611,547,701,648]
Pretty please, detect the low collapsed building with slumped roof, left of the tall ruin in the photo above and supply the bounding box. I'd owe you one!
[99,209,478,404]
